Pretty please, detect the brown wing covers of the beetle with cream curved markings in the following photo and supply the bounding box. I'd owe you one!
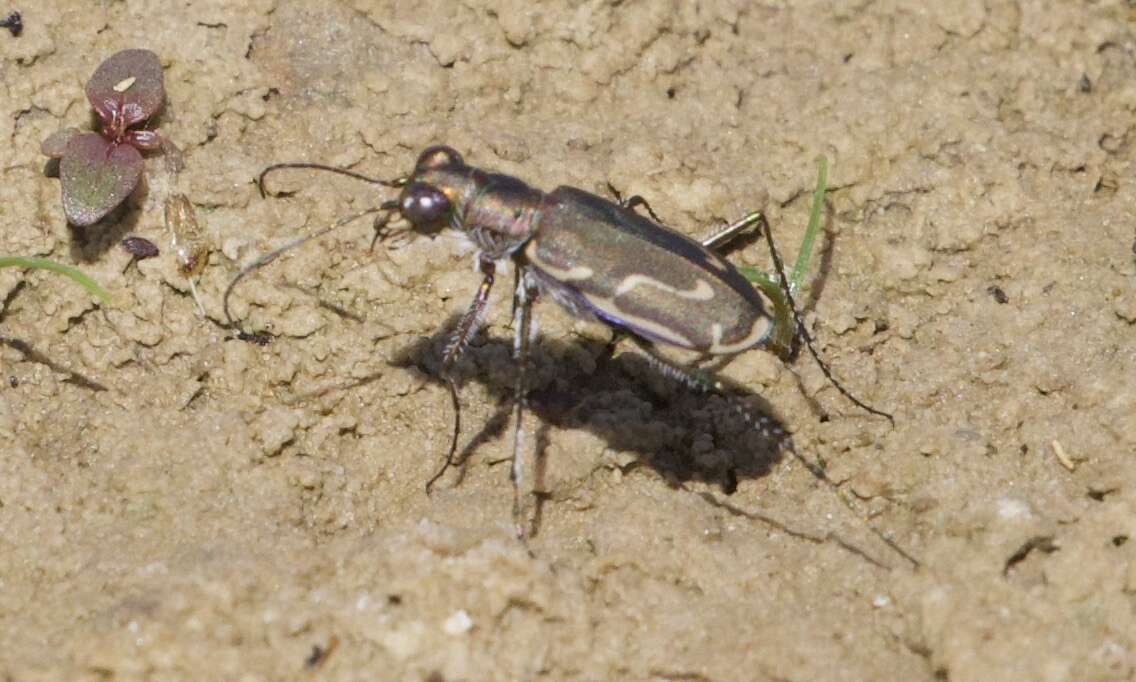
[524,186,772,354]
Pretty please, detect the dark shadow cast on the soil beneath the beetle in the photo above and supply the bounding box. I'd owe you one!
[391,316,784,500]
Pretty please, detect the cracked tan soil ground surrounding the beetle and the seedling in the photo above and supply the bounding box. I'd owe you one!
[0,0,1136,682]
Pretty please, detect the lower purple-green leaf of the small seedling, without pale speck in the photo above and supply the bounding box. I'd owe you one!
[59,133,142,225]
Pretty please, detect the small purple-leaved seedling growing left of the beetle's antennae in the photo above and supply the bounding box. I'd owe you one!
[40,49,177,226]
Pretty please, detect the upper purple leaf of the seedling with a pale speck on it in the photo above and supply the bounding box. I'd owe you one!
[86,50,166,134]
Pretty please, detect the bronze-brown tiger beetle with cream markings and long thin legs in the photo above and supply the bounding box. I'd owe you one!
[223,145,894,554]
